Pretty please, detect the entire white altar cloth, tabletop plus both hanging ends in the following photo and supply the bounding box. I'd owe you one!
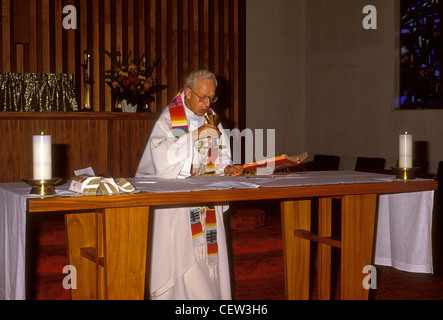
[0,171,434,300]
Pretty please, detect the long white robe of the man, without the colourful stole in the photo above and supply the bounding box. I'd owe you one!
[136,96,232,300]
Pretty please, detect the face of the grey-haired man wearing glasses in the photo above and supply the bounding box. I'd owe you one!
[185,78,216,116]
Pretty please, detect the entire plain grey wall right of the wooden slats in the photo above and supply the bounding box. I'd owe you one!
[246,0,443,173]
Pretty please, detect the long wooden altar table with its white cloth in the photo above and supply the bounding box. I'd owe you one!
[0,171,437,299]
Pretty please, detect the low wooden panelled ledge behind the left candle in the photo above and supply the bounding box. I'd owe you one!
[0,112,156,182]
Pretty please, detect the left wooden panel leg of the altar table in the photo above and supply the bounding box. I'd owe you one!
[65,206,149,300]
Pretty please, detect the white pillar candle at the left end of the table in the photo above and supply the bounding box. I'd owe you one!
[32,132,52,180]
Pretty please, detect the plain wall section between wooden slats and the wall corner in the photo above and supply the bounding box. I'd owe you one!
[246,0,305,159]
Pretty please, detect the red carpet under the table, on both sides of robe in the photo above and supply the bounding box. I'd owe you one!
[31,205,284,300]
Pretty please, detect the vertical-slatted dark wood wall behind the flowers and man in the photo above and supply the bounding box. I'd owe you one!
[0,0,246,129]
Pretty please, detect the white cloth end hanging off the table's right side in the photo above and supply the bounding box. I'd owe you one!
[374,191,434,273]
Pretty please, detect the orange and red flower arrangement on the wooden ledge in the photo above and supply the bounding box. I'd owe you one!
[105,50,167,106]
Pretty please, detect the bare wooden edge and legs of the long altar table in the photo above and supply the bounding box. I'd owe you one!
[27,178,438,300]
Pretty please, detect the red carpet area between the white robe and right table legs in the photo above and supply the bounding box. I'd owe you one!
[230,207,285,300]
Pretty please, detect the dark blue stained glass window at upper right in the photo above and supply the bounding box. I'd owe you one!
[399,0,443,109]
